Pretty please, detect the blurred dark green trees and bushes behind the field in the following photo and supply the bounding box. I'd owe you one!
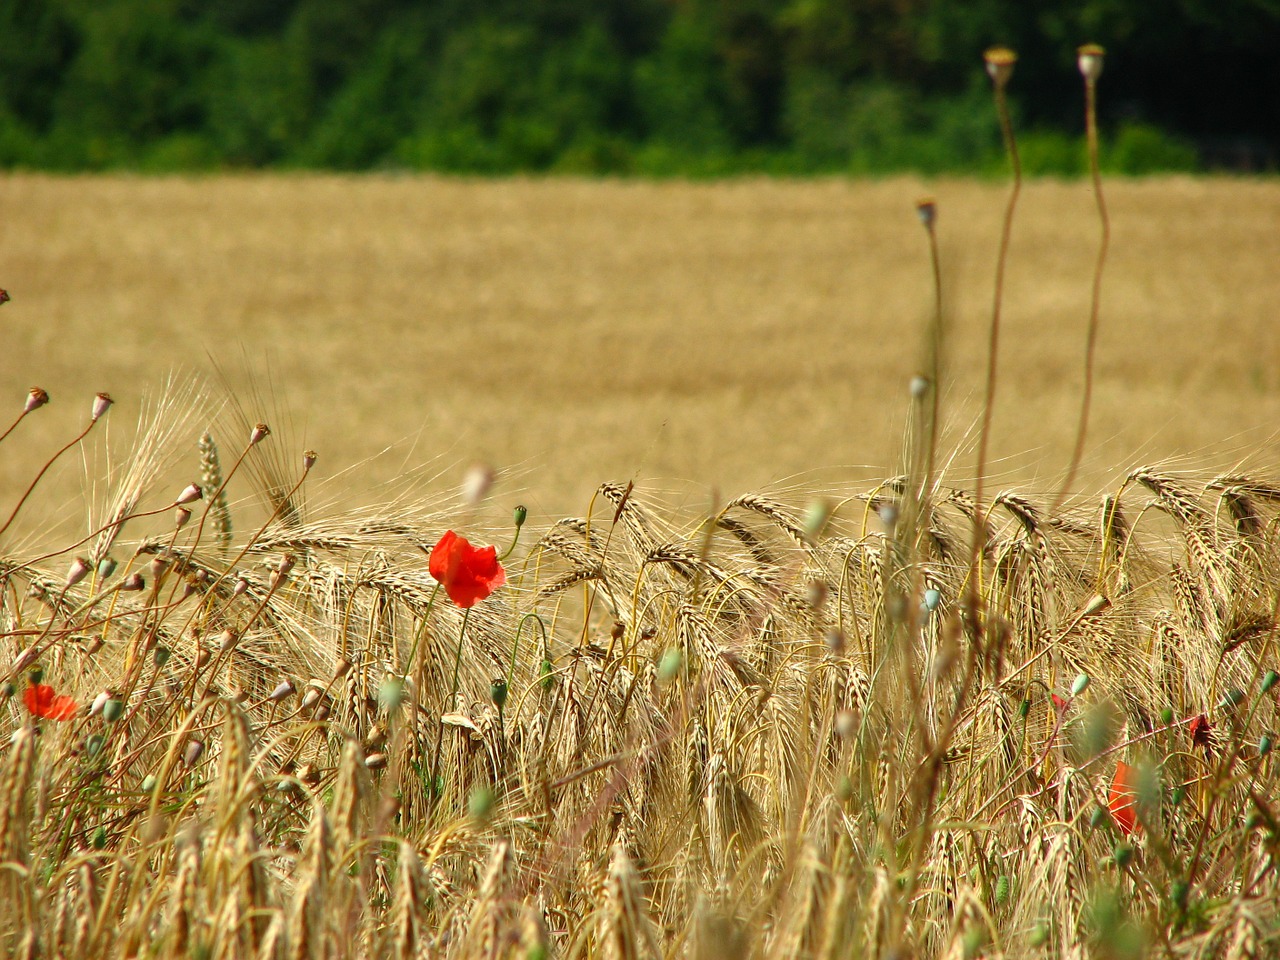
[0,0,1280,174]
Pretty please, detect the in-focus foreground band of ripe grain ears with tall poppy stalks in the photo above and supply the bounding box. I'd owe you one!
[0,47,1280,959]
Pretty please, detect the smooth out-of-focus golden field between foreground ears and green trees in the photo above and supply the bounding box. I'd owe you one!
[0,174,1280,524]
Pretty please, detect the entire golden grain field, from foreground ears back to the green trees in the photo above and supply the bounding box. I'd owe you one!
[0,177,1280,960]
